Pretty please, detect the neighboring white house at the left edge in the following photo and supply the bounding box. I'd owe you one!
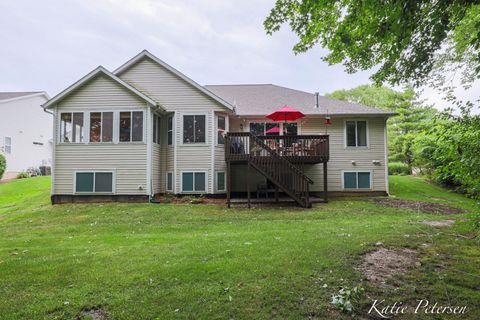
[0,92,53,179]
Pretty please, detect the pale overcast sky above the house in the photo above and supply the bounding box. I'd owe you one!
[0,0,480,112]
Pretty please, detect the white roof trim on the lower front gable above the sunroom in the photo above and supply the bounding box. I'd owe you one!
[42,66,158,109]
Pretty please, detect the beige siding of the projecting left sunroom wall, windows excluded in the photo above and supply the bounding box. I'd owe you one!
[52,75,151,195]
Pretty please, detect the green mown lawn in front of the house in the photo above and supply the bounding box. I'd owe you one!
[0,177,480,319]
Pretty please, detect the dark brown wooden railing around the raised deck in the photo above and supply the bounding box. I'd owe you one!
[225,132,329,162]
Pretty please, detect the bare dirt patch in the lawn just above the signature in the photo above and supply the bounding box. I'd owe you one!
[357,248,418,286]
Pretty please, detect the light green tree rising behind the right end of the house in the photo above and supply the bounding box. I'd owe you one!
[327,85,437,167]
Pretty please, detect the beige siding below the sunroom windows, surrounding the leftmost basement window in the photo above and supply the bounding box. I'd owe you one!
[54,144,147,195]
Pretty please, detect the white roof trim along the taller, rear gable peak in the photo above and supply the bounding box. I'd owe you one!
[113,50,233,111]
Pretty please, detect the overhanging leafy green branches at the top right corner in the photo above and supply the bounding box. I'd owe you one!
[264,0,480,86]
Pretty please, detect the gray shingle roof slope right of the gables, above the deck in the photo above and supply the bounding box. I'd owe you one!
[205,84,395,116]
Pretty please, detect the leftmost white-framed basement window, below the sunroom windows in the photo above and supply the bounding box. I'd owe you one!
[75,171,114,193]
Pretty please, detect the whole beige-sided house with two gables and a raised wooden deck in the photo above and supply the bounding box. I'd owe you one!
[43,50,394,206]
